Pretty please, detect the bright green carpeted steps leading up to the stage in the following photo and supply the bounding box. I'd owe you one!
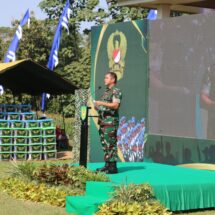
[66,181,113,215]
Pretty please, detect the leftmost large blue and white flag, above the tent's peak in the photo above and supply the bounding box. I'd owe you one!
[4,10,30,63]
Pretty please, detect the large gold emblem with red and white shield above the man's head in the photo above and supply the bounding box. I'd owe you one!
[107,31,127,80]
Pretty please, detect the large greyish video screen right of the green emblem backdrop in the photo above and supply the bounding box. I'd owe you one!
[149,13,215,139]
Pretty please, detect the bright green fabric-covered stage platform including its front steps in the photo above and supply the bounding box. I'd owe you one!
[66,162,215,215]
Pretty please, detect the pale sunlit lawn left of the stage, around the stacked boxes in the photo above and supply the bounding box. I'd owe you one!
[0,114,74,215]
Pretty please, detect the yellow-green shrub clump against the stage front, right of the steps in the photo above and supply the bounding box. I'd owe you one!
[96,184,171,215]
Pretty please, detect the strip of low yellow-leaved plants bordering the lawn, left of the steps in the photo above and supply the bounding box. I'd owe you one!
[0,178,75,207]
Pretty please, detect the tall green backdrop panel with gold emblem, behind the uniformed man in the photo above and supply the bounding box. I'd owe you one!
[90,20,148,162]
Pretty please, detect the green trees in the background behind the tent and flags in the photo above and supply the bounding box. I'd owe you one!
[0,0,150,117]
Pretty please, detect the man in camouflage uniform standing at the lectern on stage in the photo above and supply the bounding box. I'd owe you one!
[95,72,122,174]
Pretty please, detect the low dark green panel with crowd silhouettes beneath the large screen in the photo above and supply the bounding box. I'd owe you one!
[145,135,215,165]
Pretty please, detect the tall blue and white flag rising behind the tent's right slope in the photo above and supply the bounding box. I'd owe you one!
[41,0,70,112]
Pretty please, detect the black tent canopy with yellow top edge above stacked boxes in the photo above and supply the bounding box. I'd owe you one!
[0,60,78,95]
